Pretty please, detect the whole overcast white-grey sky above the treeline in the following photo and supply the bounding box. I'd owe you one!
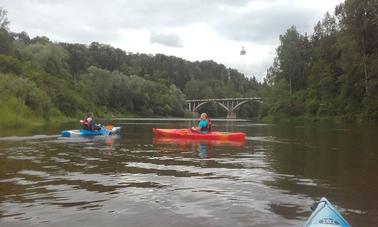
[0,0,343,81]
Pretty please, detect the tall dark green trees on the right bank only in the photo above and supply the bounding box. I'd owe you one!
[265,0,378,121]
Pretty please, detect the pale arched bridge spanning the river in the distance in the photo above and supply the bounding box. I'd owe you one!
[185,97,263,118]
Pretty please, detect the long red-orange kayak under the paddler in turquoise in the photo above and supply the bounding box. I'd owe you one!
[152,128,245,140]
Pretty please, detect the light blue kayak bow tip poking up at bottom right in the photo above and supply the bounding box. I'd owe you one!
[304,197,350,227]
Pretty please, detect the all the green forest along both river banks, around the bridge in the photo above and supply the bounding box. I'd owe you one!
[0,0,378,127]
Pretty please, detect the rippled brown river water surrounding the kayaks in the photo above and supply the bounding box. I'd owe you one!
[0,119,378,227]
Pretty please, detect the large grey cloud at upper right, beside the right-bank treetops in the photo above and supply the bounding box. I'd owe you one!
[213,0,336,44]
